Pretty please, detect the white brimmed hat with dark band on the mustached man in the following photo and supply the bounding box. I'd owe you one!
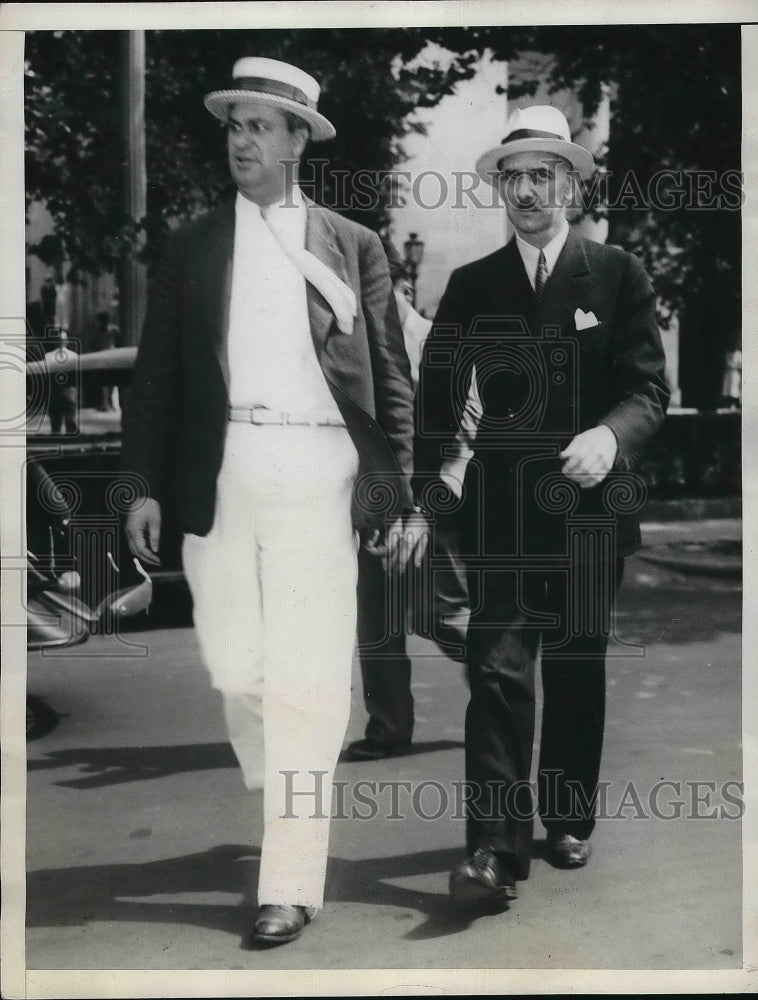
[476,104,595,187]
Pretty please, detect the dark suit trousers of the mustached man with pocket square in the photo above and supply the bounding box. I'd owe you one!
[466,559,624,878]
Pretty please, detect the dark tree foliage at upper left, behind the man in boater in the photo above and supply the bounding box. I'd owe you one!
[26,29,477,276]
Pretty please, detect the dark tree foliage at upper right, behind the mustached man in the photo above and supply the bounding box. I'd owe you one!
[432,24,742,336]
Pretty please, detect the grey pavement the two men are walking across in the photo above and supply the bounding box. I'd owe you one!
[20,504,743,980]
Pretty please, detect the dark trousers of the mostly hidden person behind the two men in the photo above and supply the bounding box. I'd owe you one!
[358,519,468,743]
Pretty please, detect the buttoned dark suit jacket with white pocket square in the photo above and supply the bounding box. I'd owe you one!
[414,230,669,555]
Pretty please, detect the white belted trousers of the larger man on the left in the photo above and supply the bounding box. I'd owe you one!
[182,422,358,909]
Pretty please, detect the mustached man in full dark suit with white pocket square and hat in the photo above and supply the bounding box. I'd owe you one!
[415,106,668,905]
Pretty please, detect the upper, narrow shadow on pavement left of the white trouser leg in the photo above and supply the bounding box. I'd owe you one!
[27,743,238,789]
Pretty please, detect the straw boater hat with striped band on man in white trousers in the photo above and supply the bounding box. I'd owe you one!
[204,57,337,141]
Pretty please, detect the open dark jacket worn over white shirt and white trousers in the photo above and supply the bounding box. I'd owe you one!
[122,202,413,535]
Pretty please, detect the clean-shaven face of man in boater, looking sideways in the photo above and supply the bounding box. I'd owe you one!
[227,101,306,205]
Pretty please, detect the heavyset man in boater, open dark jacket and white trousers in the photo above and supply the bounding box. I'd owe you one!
[124,58,425,943]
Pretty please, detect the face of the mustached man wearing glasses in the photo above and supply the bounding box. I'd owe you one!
[498,153,571,247]
